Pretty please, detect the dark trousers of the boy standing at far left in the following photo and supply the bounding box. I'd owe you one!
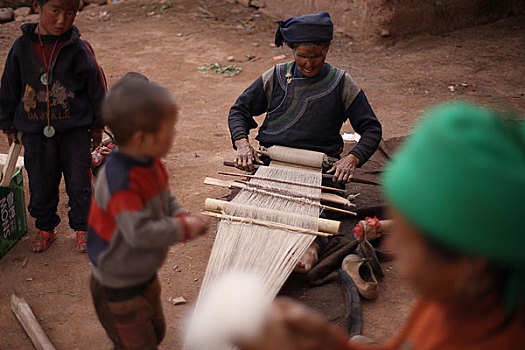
[22,128,91,231]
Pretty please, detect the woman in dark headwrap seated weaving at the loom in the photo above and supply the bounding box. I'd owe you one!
[228,12,381,272]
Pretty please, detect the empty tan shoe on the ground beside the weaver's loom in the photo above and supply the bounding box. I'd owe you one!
[341,254,379,300]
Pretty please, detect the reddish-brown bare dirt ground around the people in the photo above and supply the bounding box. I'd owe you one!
[0,0,525,349]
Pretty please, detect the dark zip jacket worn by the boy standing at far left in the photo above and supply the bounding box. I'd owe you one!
[0,24,105,133]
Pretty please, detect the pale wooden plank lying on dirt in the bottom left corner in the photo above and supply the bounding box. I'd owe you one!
[11,294,55,350]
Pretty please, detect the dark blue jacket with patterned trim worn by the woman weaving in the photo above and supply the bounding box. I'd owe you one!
[228,61,382,165]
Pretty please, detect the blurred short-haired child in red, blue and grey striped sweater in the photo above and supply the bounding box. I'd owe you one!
[87,79,208,349]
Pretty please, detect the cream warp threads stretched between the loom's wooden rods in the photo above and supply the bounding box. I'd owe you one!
[185,166,322,350]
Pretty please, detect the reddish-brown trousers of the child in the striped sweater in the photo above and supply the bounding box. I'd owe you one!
[91,275,166,350]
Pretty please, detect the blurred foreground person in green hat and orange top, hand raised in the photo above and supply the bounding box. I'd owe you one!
[238,103,525,350]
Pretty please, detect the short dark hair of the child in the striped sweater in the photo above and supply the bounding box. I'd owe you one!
[102,77,177,145]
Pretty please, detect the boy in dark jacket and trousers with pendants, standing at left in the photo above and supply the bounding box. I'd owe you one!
[0,0,106,252]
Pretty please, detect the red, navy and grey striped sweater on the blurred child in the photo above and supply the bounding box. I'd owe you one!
[87,150,185,288]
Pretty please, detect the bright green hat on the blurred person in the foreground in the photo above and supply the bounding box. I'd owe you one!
[383,103,525,311]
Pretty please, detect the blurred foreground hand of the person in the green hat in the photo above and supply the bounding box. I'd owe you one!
[237,298,350,350]
